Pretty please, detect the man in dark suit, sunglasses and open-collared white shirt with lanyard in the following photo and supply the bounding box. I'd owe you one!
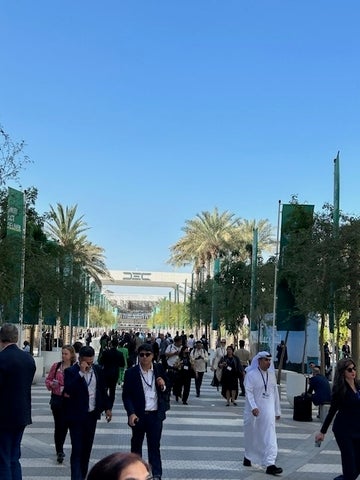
[122,343,170,480]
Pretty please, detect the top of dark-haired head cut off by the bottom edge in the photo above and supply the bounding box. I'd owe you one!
[87,453,152,480]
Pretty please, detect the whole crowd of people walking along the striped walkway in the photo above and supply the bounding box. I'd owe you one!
[0,324,360,480]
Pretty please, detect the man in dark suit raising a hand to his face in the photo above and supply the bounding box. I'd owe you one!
[63,346,112,480]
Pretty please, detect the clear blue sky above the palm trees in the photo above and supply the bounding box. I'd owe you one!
[0,0,360,284]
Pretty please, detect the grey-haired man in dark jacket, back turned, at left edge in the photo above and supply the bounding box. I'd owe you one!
[0,323,36,480]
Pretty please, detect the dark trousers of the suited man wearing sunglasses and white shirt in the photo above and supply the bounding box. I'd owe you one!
[131,411,163,477]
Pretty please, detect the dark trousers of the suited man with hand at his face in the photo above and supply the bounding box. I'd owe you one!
[69,412,97,480]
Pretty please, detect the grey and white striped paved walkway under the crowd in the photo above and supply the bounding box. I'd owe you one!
[21,372,341,480]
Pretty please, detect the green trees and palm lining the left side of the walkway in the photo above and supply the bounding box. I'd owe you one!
[0,188,110,326]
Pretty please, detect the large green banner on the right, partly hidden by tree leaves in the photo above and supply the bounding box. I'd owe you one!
[276,204,314,331]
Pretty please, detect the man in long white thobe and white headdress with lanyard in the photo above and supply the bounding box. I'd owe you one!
[243,352,282,475]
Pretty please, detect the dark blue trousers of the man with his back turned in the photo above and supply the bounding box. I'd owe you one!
[0,426,25,480]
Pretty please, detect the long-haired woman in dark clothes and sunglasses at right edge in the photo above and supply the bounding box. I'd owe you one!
[315,358,360,480]
